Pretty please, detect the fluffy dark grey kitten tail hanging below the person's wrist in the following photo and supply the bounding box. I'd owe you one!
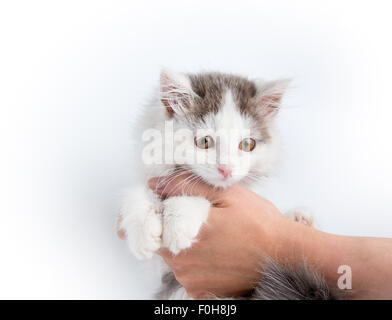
[248,259,342,300]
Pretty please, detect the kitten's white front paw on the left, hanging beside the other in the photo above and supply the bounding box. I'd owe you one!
[120,187,162,259]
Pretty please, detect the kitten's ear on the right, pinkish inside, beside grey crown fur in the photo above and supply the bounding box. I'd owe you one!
[256,79,291,116]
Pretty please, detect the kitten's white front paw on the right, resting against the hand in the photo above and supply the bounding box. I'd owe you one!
[162,196,211,254]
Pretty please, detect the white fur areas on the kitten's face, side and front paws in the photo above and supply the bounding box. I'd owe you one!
[120,72,304,299]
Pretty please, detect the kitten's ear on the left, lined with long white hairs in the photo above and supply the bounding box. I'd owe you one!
[160,70,196,117]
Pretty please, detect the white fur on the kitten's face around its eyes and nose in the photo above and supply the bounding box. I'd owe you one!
[192,90,278,188]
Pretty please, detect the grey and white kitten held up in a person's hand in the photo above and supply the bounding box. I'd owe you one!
[120,71,333,299]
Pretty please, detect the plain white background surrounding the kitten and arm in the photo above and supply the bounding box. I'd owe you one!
[0,0,392,299]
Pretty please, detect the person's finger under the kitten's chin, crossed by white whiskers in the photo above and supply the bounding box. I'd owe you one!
[148,172,224,202]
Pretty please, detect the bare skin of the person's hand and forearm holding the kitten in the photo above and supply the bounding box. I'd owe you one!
[118,177,392,299]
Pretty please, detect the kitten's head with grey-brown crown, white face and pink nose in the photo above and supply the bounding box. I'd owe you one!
[160,71,289,188]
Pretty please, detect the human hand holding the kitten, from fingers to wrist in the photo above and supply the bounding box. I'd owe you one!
[149,177,306,298]
